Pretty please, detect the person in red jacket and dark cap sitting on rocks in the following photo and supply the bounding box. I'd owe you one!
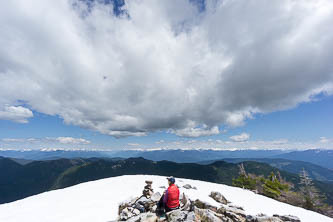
[158,177,179,212]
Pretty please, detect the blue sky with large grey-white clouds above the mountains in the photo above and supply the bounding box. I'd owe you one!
[0,0,333,150]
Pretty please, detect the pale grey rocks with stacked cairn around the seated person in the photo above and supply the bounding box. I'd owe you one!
[118,181,301,222]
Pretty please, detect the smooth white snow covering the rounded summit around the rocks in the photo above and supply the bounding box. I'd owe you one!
[0,175,333,222]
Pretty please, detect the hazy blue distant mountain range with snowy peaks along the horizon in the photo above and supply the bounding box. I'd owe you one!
[0,149,333,169]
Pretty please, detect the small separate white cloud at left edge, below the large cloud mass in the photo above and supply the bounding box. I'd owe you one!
[0,106,33,123]
